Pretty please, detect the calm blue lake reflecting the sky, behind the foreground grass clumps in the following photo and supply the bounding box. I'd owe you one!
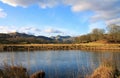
[0,50,120,78]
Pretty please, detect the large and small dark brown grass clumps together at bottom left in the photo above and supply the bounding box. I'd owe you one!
[0,64,45,78]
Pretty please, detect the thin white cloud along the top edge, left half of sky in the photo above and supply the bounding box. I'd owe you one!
[1,0,59,8]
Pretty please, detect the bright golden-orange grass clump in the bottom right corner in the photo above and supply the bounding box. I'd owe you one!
[89,60,120,78]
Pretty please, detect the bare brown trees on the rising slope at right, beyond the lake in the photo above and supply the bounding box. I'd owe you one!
[74,24,120,43]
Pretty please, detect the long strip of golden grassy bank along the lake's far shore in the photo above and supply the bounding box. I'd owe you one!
[0,43,120,51]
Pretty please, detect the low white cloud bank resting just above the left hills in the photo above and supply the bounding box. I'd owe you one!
[0,26,68,36]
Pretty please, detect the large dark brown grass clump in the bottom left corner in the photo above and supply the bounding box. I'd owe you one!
[0,64,29,78]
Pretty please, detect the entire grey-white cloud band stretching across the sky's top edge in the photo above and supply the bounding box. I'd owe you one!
[0,0,120,23]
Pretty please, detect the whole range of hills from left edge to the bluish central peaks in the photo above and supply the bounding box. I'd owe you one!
[0,32,72,44]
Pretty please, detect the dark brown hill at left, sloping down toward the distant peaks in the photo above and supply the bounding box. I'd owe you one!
[0,32,54,44]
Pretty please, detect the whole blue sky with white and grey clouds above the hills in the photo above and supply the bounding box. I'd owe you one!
[0,0,120,36]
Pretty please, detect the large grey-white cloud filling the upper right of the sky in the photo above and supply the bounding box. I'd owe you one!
[68,0,120,23]
